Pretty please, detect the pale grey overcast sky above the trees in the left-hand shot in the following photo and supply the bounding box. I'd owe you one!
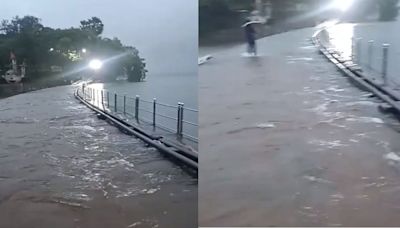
[0,0,198,74]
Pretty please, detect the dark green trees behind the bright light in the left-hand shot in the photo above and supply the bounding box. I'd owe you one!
[0,16,146,81]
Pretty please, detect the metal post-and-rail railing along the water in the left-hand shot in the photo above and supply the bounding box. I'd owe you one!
[78,85,199,143]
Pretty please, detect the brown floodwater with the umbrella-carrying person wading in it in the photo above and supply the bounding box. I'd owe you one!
[199,26,400,226]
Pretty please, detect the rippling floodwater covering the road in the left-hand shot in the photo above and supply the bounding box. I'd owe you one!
[0,86,197,228]
